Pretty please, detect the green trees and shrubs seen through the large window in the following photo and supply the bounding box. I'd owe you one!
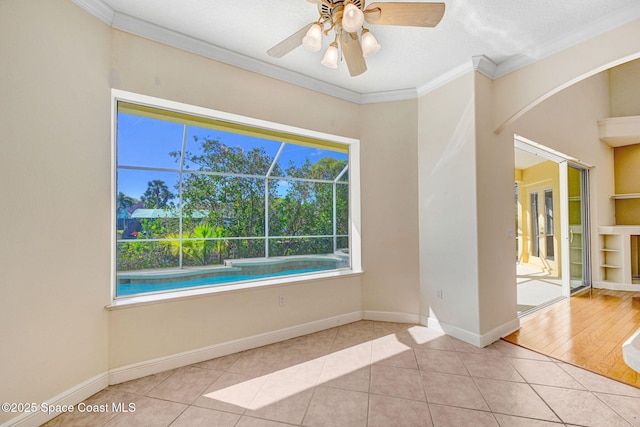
[119,137,349,269]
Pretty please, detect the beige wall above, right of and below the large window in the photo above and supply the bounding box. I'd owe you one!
[111,31,419,367]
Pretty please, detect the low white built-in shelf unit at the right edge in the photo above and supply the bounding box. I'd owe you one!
[593,225,640,291]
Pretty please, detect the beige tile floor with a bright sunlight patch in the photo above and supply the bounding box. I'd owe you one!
[45,321,640,427]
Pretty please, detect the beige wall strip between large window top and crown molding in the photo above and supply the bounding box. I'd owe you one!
[111,30,360,138]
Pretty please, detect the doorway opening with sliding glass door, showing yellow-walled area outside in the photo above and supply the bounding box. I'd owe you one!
[514,136,591,316]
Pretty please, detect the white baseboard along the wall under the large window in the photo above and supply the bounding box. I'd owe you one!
[109,311,362,385]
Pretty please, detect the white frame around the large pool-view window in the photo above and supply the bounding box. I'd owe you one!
[107,89,362,309]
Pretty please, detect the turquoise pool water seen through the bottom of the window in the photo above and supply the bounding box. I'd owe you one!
[116,268,332,297]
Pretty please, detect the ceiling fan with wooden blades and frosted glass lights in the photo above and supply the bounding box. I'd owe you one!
[267,0,445,77]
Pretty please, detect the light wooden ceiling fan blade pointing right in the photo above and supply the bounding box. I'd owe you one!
[364,2,445,27]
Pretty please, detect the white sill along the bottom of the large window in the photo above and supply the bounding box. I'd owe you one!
[105,269,363,311]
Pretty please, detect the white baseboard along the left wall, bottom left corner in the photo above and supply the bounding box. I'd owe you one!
[0,373,109,427]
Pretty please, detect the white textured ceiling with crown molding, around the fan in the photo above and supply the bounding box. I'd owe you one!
[74,0,640,98]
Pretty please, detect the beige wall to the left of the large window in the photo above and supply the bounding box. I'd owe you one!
[0,0,111,423]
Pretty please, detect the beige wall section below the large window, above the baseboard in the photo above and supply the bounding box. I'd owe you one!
[109,276,362,368]
